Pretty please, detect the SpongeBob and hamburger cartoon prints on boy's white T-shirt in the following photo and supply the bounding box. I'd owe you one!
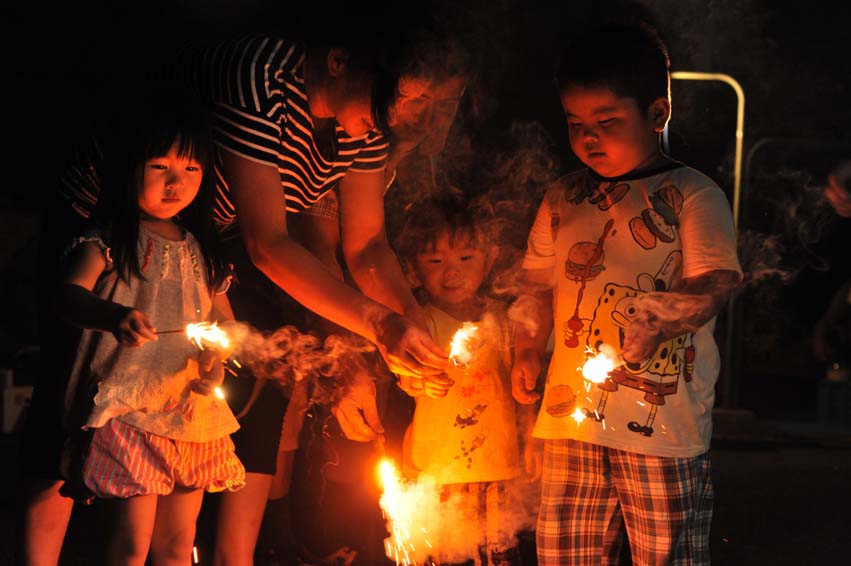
[549,171,695,442]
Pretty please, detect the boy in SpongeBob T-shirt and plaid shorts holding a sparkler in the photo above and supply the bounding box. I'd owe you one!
[512,22,741,566]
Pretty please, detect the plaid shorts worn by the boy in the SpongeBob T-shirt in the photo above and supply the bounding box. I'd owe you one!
[536,440,713,566]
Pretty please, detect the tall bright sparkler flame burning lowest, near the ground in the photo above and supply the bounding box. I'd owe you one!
[377,458,440,566]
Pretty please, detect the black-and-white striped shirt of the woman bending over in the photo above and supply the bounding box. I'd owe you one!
[62,35,389,233]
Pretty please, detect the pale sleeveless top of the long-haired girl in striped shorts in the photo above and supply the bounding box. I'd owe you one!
[66,226,239,442]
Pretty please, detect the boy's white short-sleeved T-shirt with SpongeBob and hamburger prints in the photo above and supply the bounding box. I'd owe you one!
[523,164,739,457]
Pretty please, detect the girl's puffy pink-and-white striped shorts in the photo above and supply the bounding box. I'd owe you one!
[83,419,245,498]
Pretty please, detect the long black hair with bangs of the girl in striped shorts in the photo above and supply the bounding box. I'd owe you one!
[92,88,229,296]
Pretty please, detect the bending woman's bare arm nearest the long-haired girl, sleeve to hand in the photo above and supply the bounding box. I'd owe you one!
[222,152,445,374]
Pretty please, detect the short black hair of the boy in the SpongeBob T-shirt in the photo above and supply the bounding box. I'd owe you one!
[555,22,671,109]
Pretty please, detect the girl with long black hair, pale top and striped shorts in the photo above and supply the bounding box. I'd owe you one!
[58,92,245,565]
